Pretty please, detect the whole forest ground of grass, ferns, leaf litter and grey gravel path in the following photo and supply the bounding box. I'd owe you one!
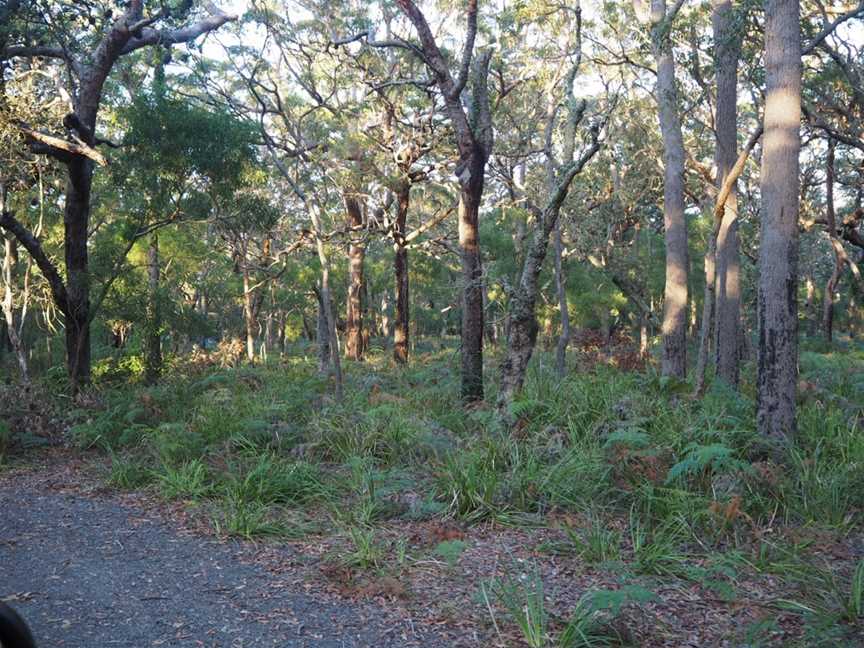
[0,336,864,648]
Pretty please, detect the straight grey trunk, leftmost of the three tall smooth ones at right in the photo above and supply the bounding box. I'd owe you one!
[651,0,688,378]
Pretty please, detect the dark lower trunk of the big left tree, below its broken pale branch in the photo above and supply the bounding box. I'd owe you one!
[63,159,95,390]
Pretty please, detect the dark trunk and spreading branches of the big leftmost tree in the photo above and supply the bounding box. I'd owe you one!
[0,0,236,387]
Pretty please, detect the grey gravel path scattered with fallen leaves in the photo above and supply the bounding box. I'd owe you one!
[0,484,447,648]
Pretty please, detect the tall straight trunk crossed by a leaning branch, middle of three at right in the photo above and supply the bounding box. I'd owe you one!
[711,0,741,387]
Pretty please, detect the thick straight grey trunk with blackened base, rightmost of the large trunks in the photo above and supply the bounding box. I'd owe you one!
[756,0,801,443]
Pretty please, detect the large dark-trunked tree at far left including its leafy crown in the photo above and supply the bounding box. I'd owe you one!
[0,0,234,386]
